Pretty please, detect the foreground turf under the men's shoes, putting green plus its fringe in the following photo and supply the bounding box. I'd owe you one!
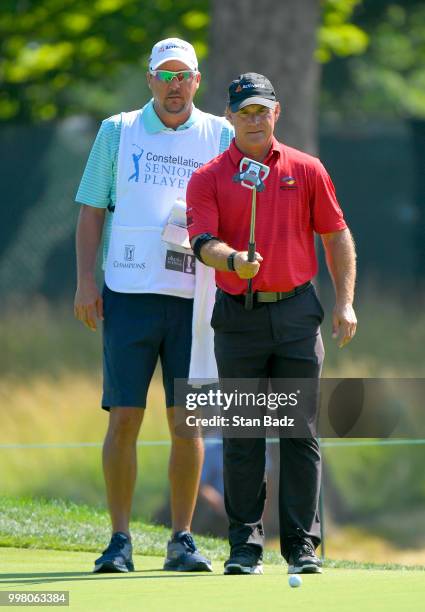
[0,497,425,612]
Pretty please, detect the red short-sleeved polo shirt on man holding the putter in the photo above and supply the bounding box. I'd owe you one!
[186,139,347,294]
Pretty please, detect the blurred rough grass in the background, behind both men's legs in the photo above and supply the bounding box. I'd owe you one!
[0,287,425,560]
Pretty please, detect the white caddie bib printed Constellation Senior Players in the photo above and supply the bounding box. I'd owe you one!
[105,109,225,298]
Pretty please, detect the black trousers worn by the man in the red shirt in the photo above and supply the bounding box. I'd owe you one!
[211,285,324,559]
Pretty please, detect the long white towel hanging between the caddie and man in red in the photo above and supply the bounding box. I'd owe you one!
[189,259,218,386]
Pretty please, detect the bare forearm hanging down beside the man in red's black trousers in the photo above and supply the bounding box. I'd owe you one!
[321,229,356,305]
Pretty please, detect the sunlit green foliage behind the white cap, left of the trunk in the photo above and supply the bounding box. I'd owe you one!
[0,0,209,121]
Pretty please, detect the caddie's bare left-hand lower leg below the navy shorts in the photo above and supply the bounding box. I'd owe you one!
[103,407,144,535]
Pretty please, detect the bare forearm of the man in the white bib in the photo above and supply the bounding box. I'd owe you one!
[76,204,105,284]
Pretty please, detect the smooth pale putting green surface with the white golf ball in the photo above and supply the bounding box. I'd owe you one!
[0,548,425,612]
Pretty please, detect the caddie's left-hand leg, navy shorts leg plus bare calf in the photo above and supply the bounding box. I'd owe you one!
[102,286,165,533]
